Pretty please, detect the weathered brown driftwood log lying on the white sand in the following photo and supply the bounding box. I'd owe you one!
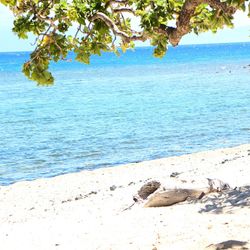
[134,179,230,207]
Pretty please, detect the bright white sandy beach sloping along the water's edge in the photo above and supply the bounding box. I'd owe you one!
[0,144,250,250]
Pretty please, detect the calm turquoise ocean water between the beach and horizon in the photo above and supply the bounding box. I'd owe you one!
[0,43,250,185]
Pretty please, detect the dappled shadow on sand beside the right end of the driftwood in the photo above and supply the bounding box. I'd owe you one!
[199,186,250,214]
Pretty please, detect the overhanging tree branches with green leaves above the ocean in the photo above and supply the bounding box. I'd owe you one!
[0,0,250,85]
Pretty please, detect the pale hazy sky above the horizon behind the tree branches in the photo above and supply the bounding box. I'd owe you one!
[0,4,250,52]
